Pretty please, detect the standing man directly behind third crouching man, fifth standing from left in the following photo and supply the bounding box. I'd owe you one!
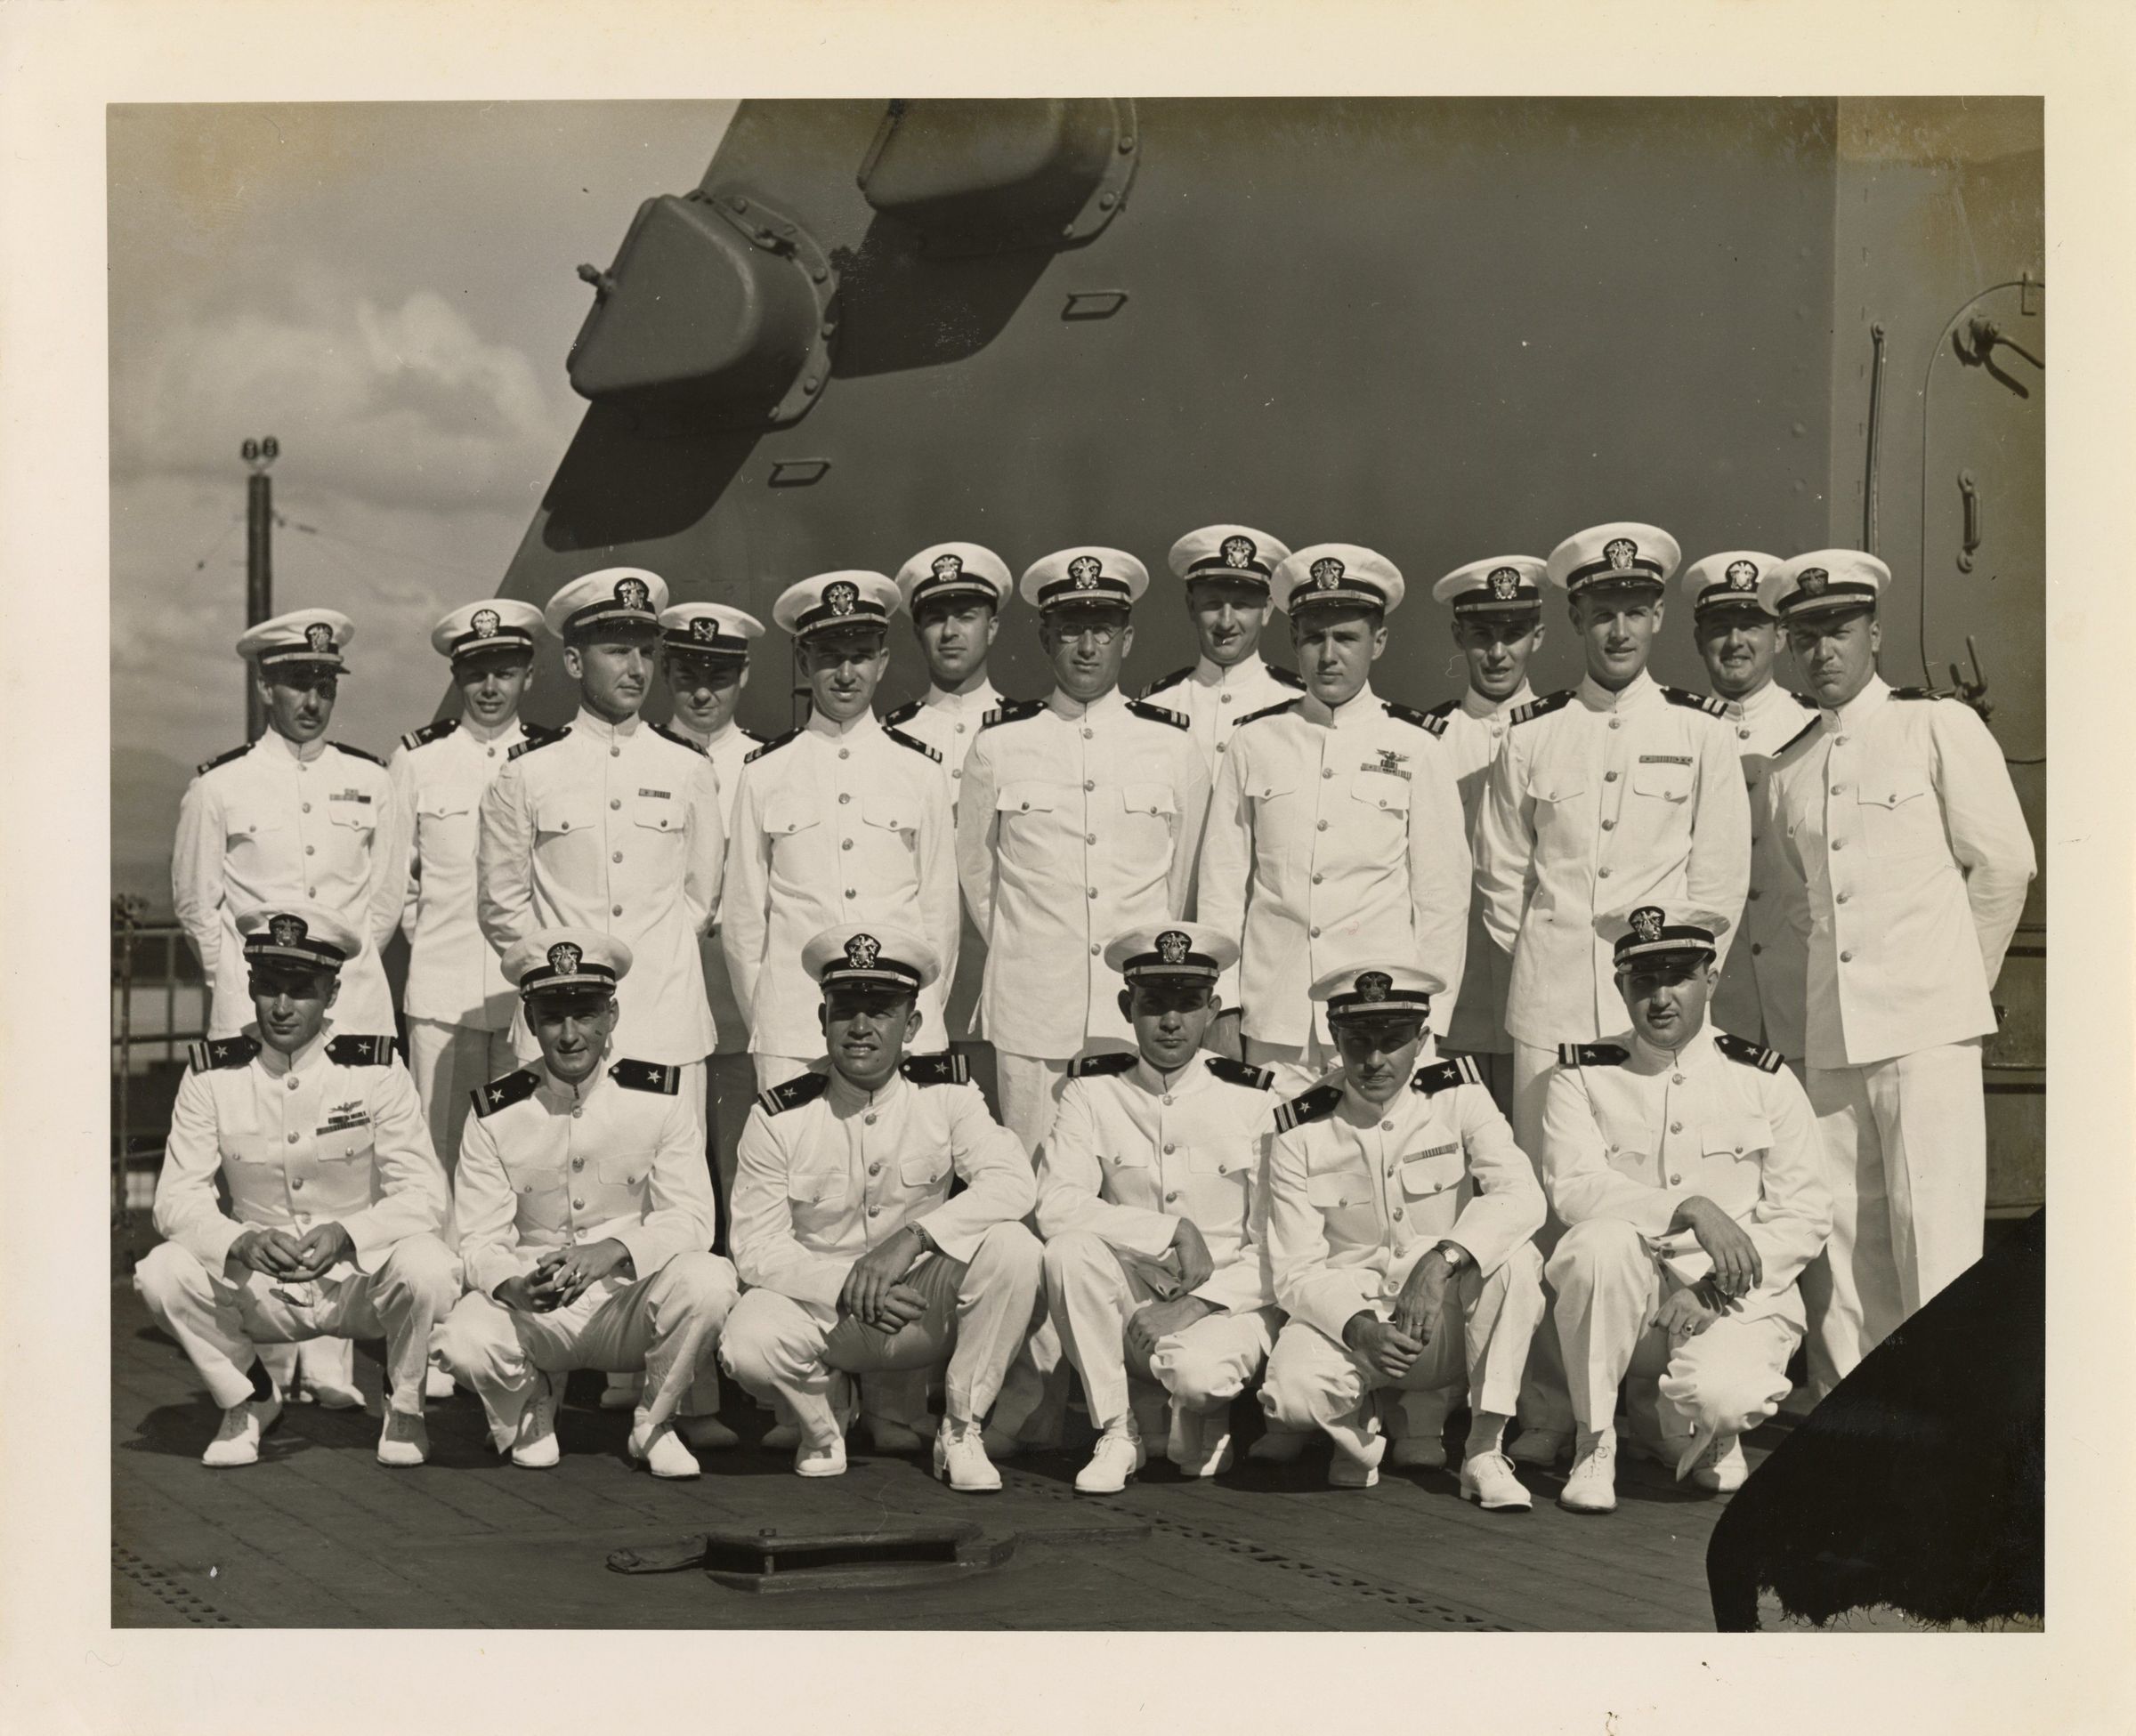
[720,572,957,1089]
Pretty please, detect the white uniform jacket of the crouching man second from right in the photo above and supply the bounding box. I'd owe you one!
[1269,1057,1544,1343]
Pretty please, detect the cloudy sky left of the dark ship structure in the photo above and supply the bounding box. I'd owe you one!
[107,102,735,908]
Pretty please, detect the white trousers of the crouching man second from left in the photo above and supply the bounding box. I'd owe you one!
[438,1251,739,1449]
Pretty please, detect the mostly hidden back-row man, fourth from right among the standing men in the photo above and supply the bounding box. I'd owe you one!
[1425,555,1547,1110]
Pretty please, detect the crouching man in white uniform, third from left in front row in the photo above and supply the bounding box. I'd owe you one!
[720,925,1040,1490]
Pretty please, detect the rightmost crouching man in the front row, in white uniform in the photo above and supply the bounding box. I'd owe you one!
[1542,905,1833,1514]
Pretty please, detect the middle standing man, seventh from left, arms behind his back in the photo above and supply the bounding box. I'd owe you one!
[957,549,1209,1153]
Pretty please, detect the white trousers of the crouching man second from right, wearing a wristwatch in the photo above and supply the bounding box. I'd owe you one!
[1260,1243,1542,1458]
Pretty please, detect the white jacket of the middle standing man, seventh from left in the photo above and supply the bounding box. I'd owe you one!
[957,690,1209,1062]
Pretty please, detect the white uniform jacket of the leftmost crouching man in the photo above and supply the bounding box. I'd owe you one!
[156,1022,447,1272]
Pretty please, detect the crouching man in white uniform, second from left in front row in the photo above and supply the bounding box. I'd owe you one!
[440,929,735,1478]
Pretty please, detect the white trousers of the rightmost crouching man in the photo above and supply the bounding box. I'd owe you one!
[1549,1217,1803,1469]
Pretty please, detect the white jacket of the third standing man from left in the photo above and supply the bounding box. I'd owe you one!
[476,711,726,1063]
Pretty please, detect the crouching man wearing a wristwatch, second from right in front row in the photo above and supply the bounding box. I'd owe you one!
[1260,965,1544,1507]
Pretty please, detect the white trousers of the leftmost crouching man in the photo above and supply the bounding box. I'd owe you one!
[134,1236,459,1416]
